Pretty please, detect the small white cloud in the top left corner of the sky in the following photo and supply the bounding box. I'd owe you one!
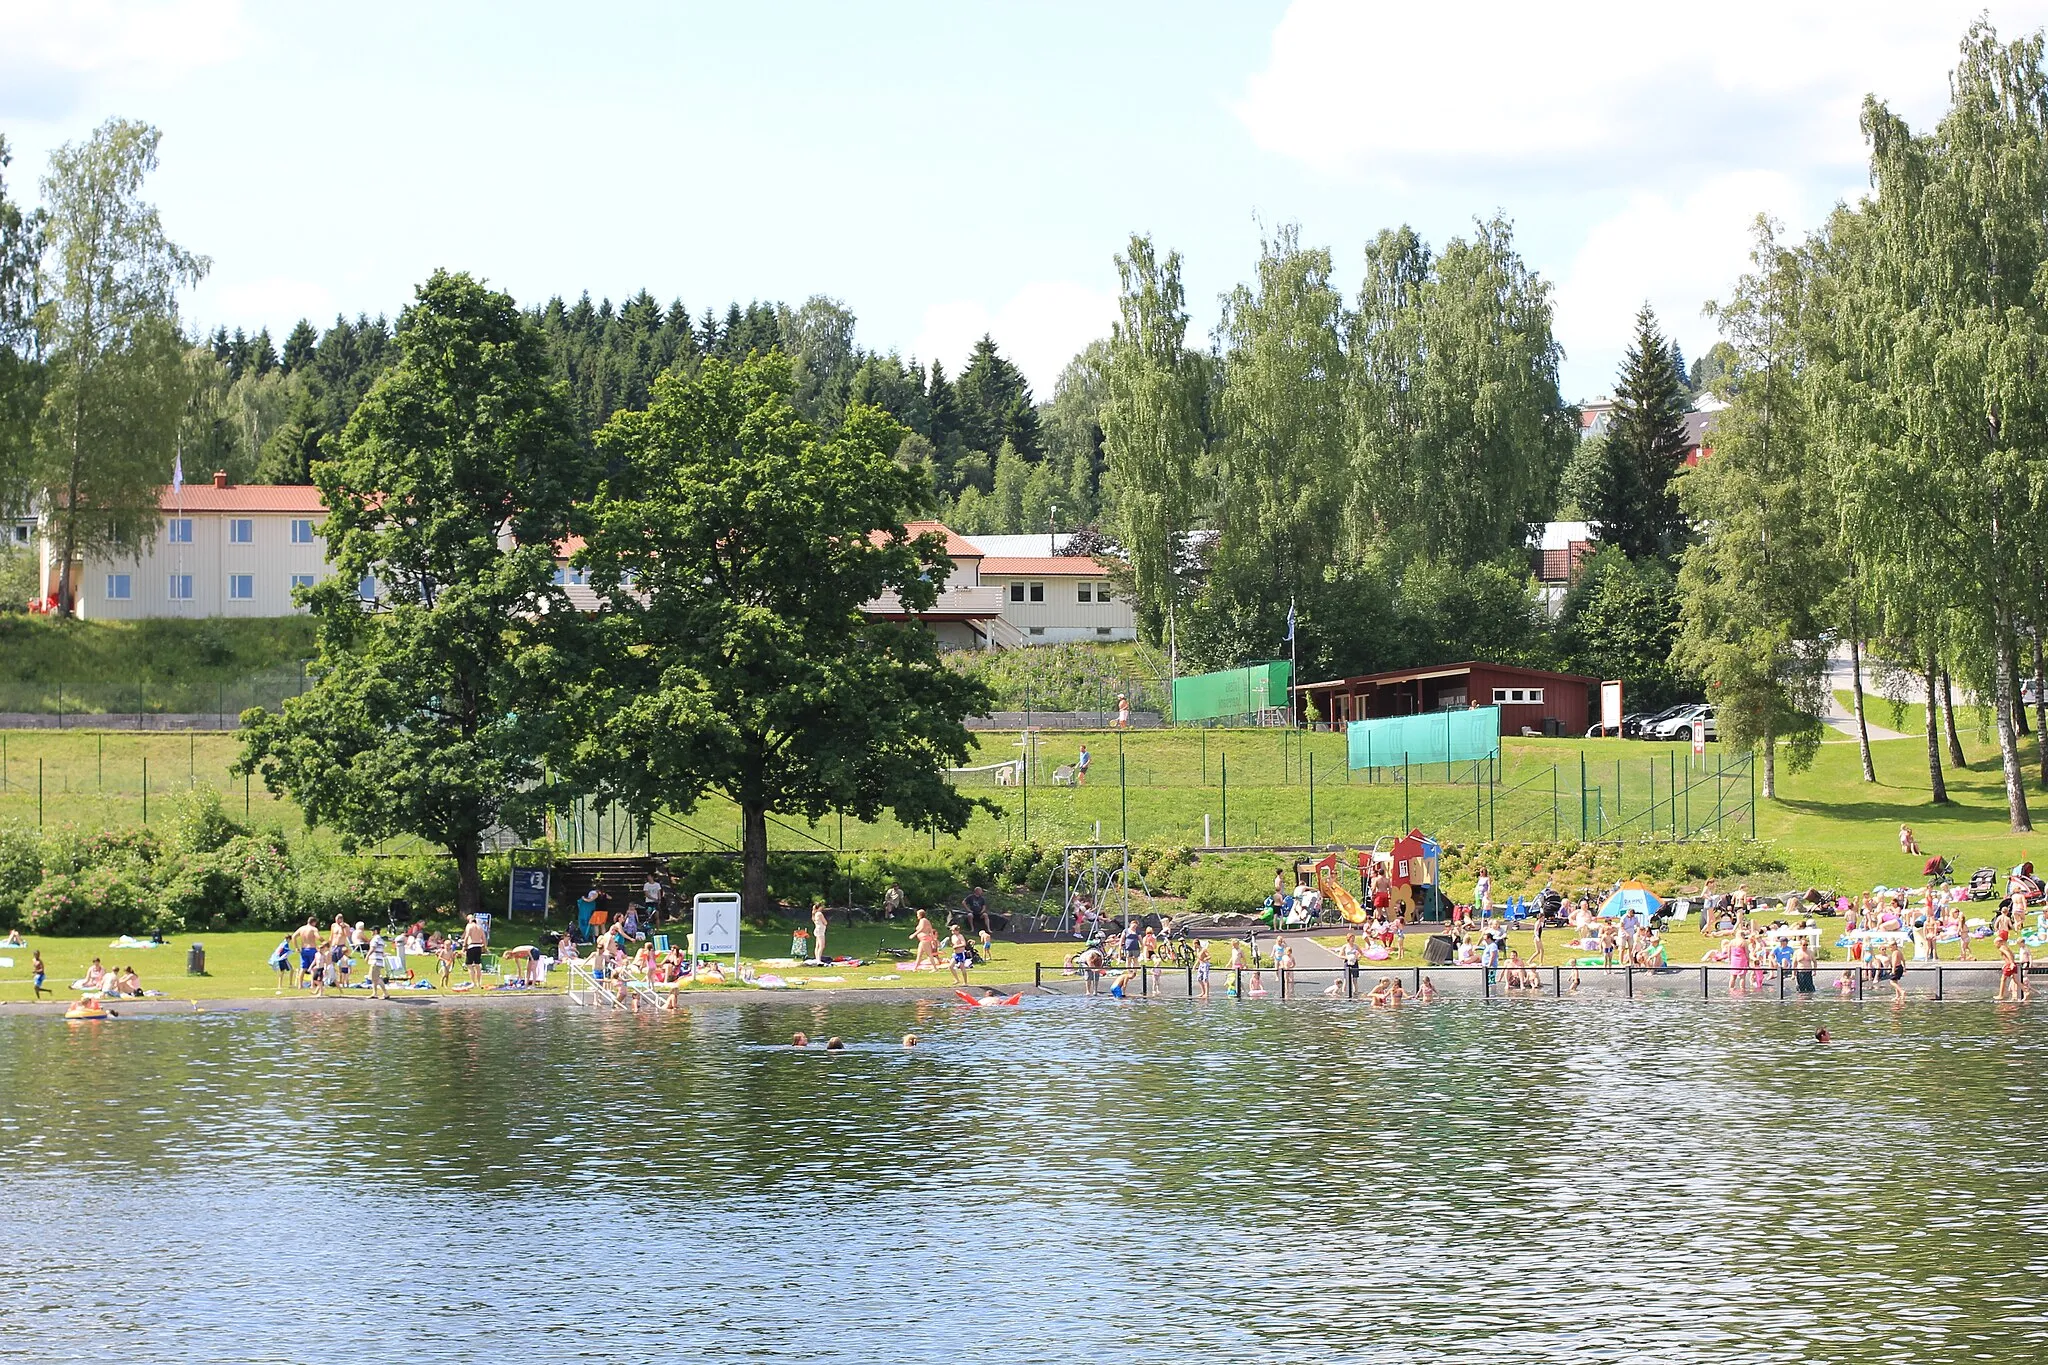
[0,0,248,119]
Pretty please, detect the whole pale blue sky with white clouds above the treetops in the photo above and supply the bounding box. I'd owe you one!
[12,0,2048,401]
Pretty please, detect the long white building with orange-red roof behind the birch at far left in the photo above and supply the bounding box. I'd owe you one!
[41,475,332,620]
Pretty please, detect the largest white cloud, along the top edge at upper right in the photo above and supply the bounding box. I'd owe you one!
[1235,0,2048,184]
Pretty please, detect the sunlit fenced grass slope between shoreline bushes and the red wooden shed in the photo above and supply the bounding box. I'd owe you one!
[0,720,2048,912]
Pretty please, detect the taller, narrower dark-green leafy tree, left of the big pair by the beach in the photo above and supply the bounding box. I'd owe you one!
[242,272,590,913]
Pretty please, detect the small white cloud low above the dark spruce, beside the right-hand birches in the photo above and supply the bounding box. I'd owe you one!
[1554,172,1817,397]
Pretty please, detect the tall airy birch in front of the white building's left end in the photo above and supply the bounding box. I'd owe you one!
[37,119,207,614]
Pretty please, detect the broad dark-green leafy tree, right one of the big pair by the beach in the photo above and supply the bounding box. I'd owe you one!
[580,354,989,915]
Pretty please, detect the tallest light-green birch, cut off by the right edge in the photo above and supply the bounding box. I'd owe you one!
[1829,20,2048,829]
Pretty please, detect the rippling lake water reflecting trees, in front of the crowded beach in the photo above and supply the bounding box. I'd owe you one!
[0,1001,2048,1363]
